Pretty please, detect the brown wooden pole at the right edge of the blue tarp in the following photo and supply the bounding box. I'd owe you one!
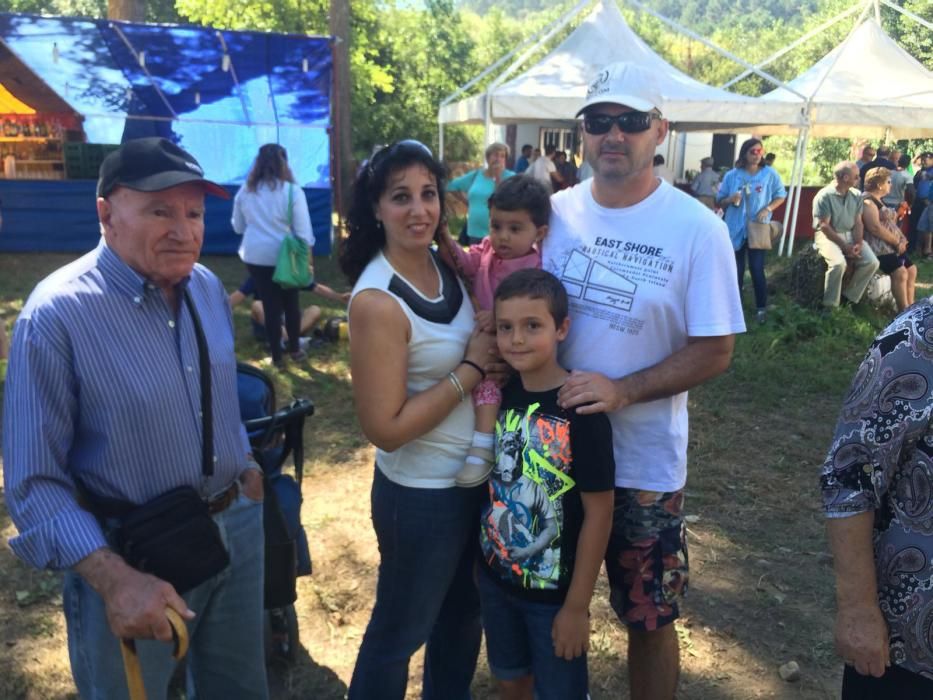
[330,0,353,233]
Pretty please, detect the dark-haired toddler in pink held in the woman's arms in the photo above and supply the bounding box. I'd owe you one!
[440,175,551,487]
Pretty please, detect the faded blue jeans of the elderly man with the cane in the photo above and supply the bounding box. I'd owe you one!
[63,494,269,700]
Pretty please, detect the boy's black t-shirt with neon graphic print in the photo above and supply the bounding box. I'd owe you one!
[480,377,615,603]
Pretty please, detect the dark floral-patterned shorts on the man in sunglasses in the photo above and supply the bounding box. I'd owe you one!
[606,488,689,631]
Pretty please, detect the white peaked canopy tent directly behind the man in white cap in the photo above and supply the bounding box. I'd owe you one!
[438,0,804,152]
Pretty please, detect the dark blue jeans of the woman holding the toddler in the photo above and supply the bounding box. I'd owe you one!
[348,467,485,700]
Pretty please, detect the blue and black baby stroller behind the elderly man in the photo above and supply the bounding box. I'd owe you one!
[237,362,314,661]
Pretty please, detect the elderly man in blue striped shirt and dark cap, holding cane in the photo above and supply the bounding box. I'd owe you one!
[3,138,268,698]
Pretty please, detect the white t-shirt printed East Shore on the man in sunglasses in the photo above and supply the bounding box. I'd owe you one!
[542,182,745,492]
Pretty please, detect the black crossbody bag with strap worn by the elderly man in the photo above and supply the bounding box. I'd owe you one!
[75,290,230,593]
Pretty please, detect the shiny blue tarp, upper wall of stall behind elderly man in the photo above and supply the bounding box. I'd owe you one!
[0,14,332,254]
